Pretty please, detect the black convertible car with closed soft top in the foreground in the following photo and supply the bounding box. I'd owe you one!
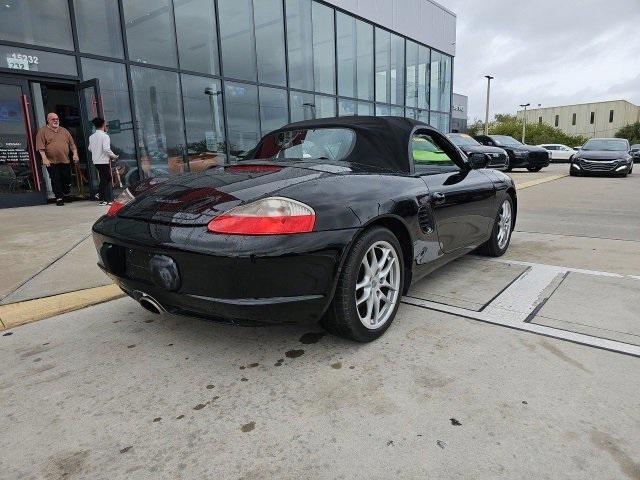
[93,117,517,342]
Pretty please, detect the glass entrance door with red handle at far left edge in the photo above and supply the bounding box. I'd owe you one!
[0,77,46,208]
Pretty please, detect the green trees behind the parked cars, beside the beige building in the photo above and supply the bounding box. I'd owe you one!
[467,113,587,147]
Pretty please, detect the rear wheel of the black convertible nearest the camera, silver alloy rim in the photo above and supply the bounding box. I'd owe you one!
[321,227,404,343]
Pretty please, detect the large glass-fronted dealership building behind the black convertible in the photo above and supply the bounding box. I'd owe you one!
[0,0,456,208]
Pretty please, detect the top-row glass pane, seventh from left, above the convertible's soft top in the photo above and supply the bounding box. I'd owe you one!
[286,0,314,90]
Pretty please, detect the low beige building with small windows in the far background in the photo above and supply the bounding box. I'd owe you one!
[518,100,640,138]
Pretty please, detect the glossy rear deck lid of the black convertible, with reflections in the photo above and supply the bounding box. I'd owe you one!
[118,162,342,226]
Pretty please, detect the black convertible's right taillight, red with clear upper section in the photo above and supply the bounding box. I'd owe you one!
[208,197,316,235]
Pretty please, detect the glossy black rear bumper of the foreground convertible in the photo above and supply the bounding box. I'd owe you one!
[93,219,357,323]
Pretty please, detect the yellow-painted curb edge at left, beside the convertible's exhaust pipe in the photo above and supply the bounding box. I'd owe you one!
[0,284,125,331]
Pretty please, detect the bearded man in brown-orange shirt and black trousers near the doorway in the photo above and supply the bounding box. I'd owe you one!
[36,113,80,206]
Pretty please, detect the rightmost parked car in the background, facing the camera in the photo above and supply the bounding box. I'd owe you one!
[569,138,633,177]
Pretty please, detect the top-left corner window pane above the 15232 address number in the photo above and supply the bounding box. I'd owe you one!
[0,0,73,50]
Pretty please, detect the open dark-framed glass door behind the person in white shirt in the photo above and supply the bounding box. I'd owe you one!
[76,78,104,198]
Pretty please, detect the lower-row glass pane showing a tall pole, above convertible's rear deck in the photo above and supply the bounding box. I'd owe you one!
[181,75,227,172]
